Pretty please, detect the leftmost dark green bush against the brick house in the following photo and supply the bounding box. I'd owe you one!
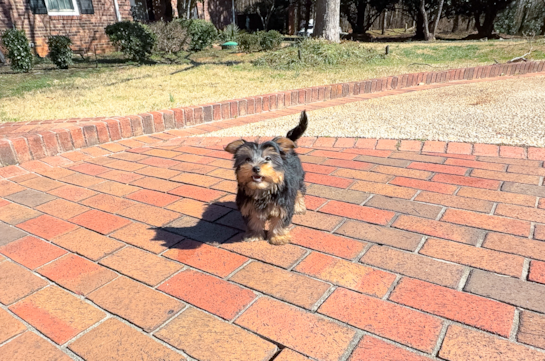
[2,29,33,73]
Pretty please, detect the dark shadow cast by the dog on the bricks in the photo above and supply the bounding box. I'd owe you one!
[152,202,249,249]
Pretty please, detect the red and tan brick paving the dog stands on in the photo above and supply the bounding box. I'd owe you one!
[0,77,545,361]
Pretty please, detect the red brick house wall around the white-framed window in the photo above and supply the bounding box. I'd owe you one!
[0,0,132,56]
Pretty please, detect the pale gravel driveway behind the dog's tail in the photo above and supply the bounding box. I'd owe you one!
[200,76,545,146]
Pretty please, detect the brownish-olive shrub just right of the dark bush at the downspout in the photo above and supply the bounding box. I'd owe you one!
[148,21,190,55]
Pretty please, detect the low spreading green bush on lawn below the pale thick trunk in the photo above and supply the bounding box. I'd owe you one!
[254,39,382,70]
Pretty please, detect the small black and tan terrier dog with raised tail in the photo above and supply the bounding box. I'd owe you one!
[225,111,308,245]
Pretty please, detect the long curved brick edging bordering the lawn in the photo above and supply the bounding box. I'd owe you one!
[0,61,545,166]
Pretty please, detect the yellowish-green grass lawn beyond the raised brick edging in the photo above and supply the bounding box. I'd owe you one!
[0,38,545,121]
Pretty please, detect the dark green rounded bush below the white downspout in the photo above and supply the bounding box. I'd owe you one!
[106,21,155,63]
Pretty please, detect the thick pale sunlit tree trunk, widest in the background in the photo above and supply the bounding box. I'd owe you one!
[313,0,341,43]
